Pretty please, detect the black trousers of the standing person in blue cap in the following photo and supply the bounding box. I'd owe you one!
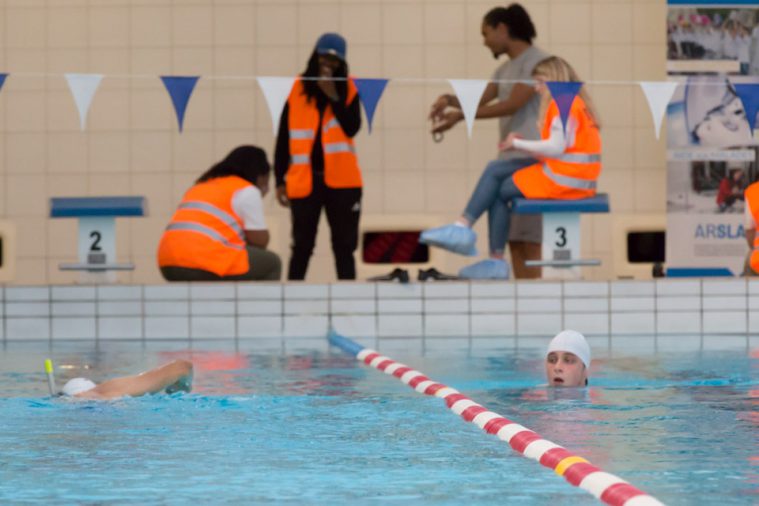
[287,175,361,280]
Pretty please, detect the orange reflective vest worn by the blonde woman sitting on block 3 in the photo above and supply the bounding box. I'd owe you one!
[513,95,601,200]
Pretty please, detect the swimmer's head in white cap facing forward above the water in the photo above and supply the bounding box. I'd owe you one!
[546,330,590,387]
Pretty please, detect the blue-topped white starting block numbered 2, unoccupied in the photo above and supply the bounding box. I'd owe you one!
[50,196,147,282]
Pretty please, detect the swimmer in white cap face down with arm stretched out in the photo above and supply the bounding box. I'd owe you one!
[61,360,192,400]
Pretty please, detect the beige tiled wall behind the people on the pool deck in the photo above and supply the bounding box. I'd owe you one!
[0,0,666,285]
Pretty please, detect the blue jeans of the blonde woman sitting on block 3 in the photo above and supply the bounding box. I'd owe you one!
[464,158,538,255]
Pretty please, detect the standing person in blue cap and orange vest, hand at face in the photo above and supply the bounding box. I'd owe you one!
[274,33,362,280]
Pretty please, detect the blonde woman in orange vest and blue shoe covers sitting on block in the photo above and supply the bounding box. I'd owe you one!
[420,56,601,279]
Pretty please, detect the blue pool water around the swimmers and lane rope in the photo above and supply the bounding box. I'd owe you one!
[0,338,759,505]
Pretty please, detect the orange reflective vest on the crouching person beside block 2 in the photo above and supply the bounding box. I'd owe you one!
[158,176,251,276]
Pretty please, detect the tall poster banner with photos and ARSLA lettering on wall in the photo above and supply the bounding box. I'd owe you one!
[666,0,759,275]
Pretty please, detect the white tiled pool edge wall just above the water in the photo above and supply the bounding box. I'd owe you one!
[0,280,759,341]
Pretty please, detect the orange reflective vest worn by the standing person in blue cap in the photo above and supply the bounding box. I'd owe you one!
[285,79,361,199]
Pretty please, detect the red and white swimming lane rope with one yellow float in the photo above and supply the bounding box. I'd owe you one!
[328,331,662,506]
